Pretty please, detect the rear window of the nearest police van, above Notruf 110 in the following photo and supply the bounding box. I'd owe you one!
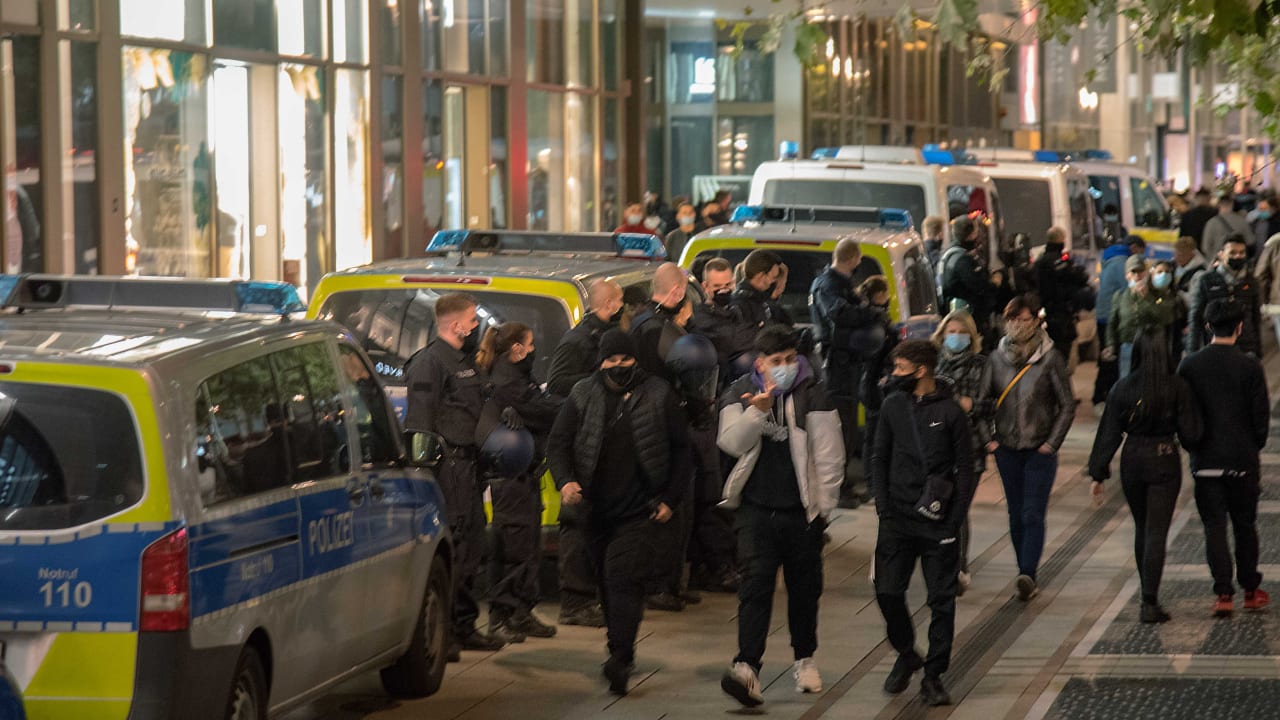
[0,383,143,530]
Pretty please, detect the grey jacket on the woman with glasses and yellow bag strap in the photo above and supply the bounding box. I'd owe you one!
[982,331,1075,452]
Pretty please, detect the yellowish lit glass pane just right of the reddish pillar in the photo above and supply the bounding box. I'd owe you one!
[525,90,564,231]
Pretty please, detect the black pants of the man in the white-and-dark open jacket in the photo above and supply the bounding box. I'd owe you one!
[733,503,824,673]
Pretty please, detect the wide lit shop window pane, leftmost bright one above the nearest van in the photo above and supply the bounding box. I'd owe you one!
[123,47,212,277]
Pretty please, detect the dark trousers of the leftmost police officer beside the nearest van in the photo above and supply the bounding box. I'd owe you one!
[436,447,486,639]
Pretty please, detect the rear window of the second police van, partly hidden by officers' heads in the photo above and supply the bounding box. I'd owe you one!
[319,288,568,384]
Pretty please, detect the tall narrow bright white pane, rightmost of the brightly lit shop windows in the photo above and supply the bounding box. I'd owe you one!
[333,69,374,269]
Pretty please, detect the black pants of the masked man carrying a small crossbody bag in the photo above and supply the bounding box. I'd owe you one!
[876,518,960,676]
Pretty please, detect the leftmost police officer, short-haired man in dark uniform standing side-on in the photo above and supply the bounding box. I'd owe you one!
[404,292,504,657]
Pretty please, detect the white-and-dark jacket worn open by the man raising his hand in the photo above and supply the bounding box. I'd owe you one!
[717,357,845,523]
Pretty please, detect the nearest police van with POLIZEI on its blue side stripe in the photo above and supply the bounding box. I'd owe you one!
[0,275,451,720]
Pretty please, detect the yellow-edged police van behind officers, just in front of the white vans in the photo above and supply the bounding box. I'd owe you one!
[680,205,941,337]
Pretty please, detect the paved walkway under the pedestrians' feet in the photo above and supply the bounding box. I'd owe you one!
[288,354,1280,720]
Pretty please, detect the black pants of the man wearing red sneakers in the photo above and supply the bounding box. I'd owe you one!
[1196,470,1262,594]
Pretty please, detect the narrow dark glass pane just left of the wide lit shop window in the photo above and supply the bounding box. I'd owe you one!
[66,41,100,273]
